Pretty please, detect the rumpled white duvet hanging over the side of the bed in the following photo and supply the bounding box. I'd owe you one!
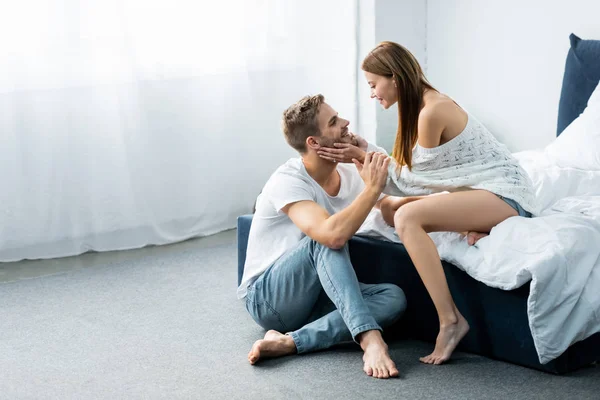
[358,150,600,364]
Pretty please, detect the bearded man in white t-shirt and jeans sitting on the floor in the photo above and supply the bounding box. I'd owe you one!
[238,95,406,378]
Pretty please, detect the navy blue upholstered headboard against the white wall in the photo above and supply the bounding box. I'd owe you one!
[556,33,600,136]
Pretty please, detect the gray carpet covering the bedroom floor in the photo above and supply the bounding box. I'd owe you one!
[0,235,600,399]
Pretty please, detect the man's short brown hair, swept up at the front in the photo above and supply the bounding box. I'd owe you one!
[282,94,325,153]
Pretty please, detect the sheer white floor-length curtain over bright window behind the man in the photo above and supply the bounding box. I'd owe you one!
[0,0,357,261]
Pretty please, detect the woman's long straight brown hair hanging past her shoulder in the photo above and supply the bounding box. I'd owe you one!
[361,42,435,169]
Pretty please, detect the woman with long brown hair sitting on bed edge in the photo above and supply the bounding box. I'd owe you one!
[321,42,535,364]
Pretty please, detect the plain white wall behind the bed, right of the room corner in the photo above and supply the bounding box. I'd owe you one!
[426,0,600,151]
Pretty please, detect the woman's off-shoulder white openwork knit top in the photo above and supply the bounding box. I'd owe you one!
[369,113,537,214]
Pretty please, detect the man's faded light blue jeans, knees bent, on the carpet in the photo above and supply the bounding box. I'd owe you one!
[246,236,406,353]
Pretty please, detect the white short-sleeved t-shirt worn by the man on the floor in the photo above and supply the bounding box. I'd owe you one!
[237,158,378,299]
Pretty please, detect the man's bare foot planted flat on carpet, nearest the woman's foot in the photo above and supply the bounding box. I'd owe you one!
[360,330,398,379]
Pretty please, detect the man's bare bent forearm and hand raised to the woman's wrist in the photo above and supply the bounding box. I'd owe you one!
[282,154,389,249]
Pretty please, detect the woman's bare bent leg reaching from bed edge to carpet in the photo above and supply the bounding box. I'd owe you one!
[394,190,517,364]
